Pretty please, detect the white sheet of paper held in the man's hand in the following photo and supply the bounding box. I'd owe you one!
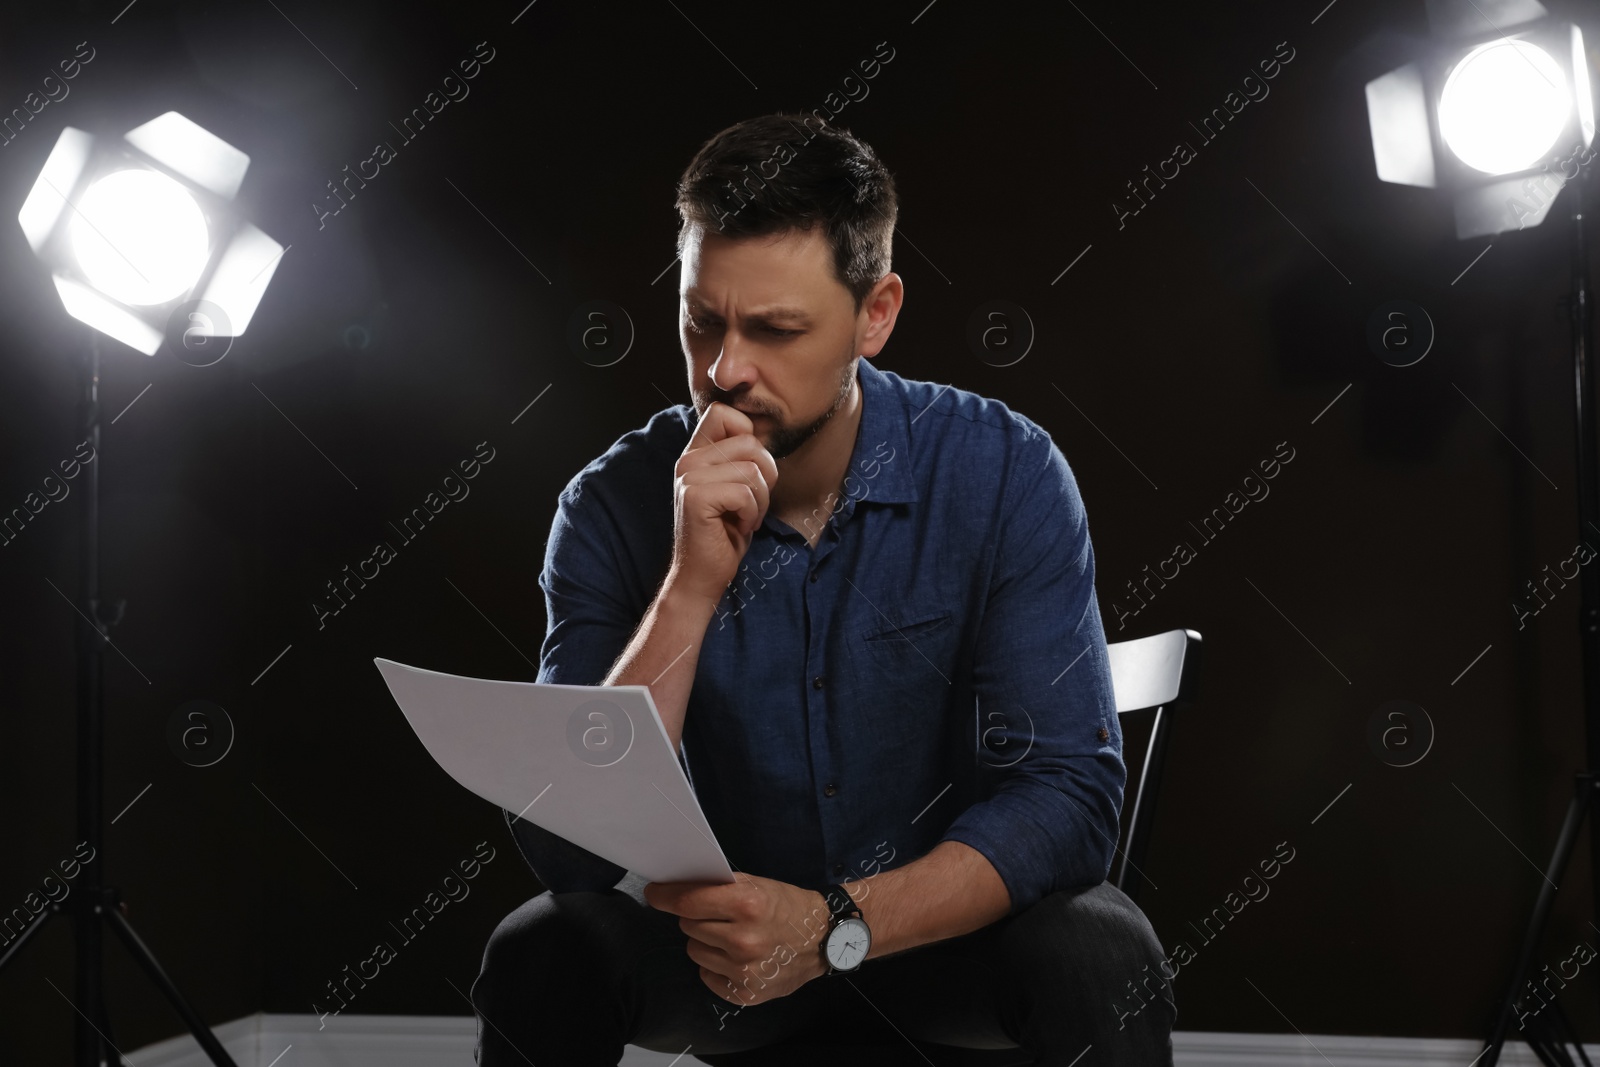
[373,659,734,883]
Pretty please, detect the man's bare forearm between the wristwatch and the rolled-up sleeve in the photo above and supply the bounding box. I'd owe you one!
[822,841,1011,960]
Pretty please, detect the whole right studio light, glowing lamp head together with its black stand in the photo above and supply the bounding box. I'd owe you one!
[1366,0,1600,1067]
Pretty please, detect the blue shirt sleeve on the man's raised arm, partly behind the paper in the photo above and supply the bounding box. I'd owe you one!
[506,480,642,893]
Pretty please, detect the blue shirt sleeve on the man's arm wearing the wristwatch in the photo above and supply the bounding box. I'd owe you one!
[942,432,1126,915]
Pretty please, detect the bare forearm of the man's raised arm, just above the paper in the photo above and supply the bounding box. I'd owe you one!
[602,574,717,752]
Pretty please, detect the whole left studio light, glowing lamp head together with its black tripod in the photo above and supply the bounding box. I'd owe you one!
[0,112,283,1067]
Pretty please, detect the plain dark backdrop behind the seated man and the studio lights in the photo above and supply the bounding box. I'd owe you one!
[0,0,1600,1064]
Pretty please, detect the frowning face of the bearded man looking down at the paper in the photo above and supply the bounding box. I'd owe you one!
[678,227,866,459]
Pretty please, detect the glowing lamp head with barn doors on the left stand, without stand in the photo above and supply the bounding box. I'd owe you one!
[18,112,283,355]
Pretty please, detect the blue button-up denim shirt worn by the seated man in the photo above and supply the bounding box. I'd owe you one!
[506,358,1126,913]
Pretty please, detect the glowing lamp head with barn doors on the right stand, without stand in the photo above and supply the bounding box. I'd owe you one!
[1366,0,1595,238]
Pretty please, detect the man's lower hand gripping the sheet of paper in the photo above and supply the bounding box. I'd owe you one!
[645,872,829,1006]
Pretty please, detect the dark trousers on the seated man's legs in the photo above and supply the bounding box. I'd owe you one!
[472,883,1178,1067]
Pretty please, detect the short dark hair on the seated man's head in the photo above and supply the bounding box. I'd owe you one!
[677,114,899,312]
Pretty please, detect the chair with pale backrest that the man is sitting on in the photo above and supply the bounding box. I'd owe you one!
[694,630,1200,1067]
